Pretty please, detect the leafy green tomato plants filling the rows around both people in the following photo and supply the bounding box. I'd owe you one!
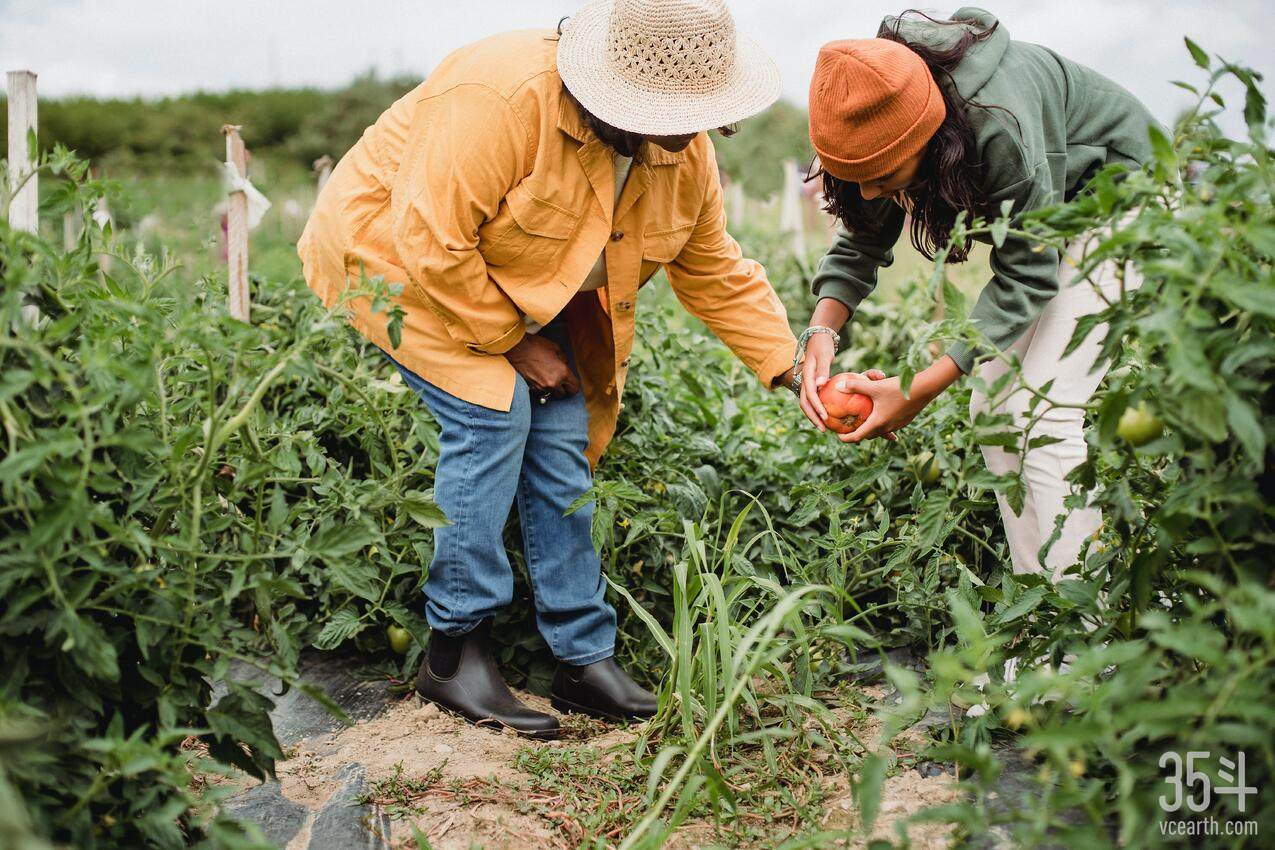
[0,41,1275,850]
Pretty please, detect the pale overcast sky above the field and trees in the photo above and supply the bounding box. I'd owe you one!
[0,0,1275,130]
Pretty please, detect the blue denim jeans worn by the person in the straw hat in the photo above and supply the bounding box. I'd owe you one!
[390,321,616,664]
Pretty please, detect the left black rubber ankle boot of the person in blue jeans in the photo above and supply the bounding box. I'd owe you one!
[416,619,558,738]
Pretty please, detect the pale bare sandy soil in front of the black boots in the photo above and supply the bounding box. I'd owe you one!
[239,692,959,850]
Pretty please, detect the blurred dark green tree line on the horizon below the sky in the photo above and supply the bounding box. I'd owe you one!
[0,73,811,198]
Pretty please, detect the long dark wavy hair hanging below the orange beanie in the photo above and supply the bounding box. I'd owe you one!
[816,9,1000,263]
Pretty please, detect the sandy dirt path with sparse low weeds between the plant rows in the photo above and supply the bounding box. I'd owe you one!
[237,693,958,850]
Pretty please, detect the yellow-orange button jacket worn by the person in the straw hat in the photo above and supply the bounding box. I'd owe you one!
[297,31,796,464]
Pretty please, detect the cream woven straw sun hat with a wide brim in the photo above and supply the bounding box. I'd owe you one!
[557,0,779,135]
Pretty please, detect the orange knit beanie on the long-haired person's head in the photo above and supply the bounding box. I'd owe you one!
[810,38,947,184]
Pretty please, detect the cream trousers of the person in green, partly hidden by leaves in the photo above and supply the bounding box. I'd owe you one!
[970,230,1141,582]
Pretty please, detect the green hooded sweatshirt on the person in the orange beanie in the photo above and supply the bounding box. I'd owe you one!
[812,6,1155,373]
